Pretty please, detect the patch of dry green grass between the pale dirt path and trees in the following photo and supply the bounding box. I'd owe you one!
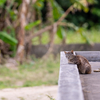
[0,56,60,89]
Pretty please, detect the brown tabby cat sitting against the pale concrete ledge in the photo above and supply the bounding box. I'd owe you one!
[64,51,91,74]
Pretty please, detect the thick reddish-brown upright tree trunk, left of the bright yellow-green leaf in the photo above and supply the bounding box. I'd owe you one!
[16,0,30,63]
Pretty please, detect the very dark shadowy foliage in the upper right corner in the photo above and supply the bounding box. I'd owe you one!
[56,0,100,29]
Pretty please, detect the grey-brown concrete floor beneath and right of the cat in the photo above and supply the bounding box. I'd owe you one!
[80,62,100,100]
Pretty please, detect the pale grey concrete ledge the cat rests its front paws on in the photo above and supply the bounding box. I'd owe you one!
[57,52,84,100]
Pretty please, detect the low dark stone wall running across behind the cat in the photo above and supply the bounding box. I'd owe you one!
[31,43,100,57]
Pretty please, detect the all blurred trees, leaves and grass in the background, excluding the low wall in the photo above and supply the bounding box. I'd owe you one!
[0,0,100,88]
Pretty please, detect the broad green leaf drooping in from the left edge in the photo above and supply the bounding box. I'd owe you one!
[0,31,17,45]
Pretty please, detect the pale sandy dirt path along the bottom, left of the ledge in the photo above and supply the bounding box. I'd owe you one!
[0,86,58,100]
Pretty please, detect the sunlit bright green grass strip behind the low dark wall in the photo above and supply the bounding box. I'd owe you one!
[33,29,100,45]
